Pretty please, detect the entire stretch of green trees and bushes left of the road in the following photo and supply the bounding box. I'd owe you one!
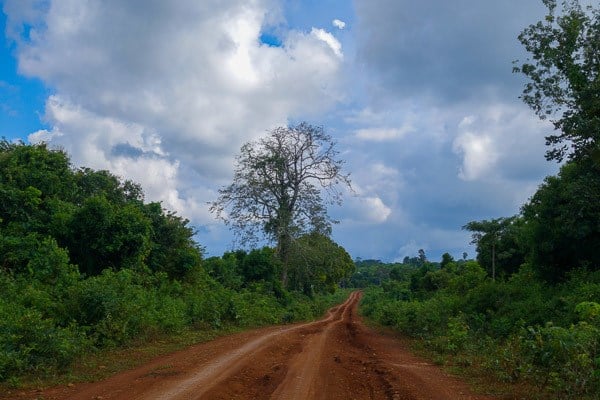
[0,140,352,384]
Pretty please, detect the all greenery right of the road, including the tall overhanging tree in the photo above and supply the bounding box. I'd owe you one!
[352,0,600,399]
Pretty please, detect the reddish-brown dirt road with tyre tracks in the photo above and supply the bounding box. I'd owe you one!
[14,292,490,400]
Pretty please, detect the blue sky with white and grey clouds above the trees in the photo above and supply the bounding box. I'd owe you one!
[0,0,558,262]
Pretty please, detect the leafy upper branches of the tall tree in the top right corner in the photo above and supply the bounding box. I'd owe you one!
[514,0,600,162]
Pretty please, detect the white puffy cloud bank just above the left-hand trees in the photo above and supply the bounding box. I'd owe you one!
[28,95,192,216]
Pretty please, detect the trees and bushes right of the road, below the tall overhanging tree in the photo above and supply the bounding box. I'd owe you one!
[352,159,600,398]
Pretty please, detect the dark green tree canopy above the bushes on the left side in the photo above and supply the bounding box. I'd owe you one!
[0,140,202,278]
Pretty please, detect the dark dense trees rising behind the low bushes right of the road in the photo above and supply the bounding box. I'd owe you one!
[463,158,600,282]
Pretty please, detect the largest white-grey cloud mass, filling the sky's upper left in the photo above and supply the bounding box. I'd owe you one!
[4,0,342,228]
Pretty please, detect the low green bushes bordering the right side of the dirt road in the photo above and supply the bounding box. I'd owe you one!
[361,260,600,398]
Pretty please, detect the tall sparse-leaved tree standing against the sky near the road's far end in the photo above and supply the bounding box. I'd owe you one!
[210,123,350,285]
